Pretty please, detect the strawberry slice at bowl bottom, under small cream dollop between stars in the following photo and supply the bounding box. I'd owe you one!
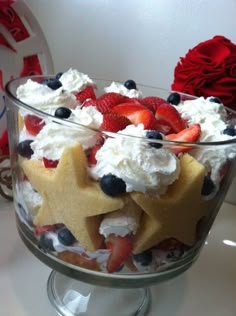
[105,234,133,273]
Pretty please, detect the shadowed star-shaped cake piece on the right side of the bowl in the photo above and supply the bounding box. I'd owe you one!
[131,154,212,253]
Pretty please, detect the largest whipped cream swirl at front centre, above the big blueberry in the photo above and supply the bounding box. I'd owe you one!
[90,124,180,195]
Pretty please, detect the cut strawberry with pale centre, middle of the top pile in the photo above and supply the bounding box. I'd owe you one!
[112,103,155,129]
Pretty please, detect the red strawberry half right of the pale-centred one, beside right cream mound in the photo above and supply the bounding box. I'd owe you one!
[155,102,186,133]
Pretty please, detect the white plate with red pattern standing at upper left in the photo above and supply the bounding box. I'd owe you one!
[0,0,53,135]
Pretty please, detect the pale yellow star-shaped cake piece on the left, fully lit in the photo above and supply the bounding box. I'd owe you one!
[21,143,124,251]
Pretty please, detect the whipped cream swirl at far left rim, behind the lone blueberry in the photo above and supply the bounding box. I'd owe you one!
[16,79,77,114]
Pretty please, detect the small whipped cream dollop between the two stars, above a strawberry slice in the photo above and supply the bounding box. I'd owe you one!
[99,210,139,237]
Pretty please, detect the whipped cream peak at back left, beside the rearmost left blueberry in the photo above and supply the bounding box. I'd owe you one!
[59,68,95,93]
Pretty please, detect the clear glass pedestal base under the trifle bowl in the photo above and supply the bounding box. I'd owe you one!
[47,271,151,316]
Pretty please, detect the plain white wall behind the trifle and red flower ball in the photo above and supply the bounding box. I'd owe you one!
[25,0,236,87]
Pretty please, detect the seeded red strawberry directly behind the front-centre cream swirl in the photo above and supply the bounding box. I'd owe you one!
[101,113,131,133]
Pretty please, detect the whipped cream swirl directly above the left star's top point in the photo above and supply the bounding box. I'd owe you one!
[31,106,103,160]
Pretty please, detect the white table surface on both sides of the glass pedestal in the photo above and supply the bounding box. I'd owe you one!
[0,197,236,316]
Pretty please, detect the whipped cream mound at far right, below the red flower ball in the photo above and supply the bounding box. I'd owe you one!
[176,97,236,186]
